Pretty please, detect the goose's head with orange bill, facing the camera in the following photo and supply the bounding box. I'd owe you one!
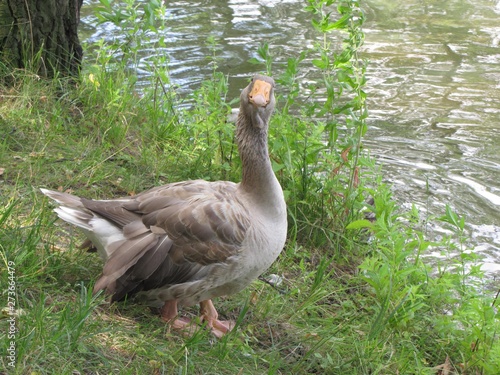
[240,74,276,129]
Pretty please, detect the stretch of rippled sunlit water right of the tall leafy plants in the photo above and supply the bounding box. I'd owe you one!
[365,0,500,271]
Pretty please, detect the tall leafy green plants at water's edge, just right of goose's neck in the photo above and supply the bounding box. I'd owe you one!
[252,1,372,253]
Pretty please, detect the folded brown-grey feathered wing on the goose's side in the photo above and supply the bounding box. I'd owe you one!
[82,180,250,300]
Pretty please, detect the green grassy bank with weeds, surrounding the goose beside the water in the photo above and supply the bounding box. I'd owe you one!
[0,2,500,374]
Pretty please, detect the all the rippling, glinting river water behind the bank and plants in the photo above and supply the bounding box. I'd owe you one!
[80,0,500,277]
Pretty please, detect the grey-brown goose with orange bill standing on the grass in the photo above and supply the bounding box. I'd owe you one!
[41,75,287,337]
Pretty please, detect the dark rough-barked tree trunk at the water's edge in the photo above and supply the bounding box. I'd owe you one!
[0,0,83,77]
